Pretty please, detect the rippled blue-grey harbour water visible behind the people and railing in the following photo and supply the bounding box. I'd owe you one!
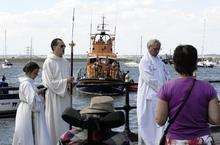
[0,61,220,145]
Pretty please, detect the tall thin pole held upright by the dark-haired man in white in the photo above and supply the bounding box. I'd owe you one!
[69,8,75,120]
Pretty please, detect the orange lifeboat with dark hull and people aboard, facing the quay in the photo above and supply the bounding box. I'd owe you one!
[76,17,126,95]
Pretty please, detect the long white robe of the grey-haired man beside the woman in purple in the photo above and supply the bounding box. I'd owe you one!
[137,52,168,145]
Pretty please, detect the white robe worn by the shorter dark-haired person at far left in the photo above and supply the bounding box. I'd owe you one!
[12,76,53,145]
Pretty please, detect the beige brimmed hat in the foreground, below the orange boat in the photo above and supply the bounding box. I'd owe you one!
[80,96,114,114]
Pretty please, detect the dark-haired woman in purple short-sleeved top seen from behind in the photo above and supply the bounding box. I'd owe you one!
[155,45,220,145]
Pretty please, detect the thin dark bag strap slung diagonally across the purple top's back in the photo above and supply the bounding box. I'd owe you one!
[164,79,196,135]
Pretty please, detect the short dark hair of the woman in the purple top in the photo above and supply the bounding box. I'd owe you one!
[173,45,198,76]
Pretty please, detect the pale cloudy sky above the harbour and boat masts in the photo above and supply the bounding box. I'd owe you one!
[0,0,220,55]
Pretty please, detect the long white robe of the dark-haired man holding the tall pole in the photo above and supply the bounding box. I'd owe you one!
[42,53,70,145]
